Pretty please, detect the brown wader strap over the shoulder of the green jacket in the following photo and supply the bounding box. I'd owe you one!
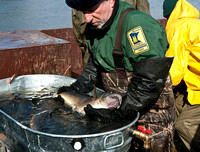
[113,8,135,71]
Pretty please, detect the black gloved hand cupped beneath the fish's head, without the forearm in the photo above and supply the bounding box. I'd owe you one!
[84,104,137,123]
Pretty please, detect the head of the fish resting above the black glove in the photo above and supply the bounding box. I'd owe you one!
[91,93,122,109]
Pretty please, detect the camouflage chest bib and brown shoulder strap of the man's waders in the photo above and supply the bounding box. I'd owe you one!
[101,8,135,95]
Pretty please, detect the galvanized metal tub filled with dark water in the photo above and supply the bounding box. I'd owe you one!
[0,74,139,152]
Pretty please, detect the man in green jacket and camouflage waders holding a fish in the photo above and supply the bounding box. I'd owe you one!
[58,0,175,152]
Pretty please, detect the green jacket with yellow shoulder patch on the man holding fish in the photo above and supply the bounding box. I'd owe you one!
[86,0,168,72]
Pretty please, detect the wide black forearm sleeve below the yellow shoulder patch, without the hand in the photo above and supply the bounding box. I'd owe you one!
[119,57,173,115]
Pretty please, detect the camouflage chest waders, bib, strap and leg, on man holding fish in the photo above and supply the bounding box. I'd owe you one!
[101,8,175,152]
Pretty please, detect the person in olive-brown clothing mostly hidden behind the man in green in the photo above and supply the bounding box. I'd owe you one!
[72,0,150,69]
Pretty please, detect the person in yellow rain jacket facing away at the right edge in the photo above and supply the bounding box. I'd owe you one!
[163,0,200,151]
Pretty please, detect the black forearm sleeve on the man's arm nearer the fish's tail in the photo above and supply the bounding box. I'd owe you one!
[70,57,98,93]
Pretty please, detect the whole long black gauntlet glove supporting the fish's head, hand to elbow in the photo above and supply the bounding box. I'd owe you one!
[84,58,173,122]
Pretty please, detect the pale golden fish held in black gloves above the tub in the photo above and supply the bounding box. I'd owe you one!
[54,91,122,115]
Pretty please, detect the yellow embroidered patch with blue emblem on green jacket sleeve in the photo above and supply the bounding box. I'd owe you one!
[127,26,149,54]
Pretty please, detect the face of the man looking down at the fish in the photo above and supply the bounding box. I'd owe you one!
[83,0,115,28]
